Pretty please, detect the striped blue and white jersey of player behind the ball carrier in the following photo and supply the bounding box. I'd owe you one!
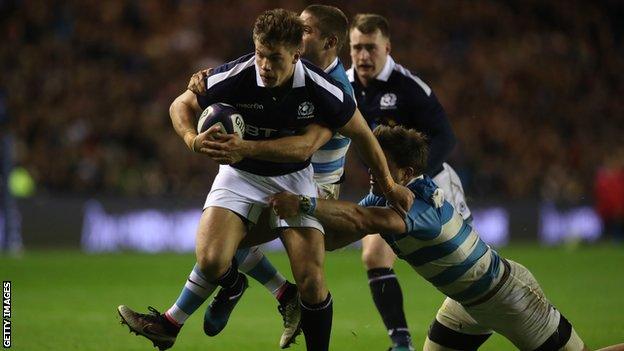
[312,58,355,184]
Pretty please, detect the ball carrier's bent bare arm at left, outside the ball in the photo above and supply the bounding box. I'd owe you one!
[169,90,218,153]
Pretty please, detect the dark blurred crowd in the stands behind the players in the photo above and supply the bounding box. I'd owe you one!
[0,0,624,216]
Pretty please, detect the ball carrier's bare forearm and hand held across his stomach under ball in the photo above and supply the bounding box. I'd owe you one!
[202,124,333,164]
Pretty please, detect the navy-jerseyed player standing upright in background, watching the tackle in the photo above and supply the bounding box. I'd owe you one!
[347,14,470,349]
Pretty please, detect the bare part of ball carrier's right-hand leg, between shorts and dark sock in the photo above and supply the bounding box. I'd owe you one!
[281,227,327,303]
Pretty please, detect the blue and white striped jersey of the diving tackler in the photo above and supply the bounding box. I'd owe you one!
[360,176,503,303]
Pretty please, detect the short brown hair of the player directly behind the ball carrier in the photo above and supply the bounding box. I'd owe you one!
[303,4,349,51]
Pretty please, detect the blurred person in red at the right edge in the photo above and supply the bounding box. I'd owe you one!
[594,150,624,242]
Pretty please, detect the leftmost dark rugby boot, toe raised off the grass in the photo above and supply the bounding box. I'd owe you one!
[117,305,180,351]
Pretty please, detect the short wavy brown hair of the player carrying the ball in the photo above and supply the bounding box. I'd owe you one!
[253,9,303,48]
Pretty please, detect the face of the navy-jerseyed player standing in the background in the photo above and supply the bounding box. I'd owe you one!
[349,28,390,81]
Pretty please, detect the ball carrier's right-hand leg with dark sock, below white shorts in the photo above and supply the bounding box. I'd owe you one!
[281,228,333,351]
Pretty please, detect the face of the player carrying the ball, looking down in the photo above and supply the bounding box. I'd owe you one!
[255,41,300,88]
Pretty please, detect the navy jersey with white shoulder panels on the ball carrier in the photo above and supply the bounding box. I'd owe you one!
[197,53,355,176]
